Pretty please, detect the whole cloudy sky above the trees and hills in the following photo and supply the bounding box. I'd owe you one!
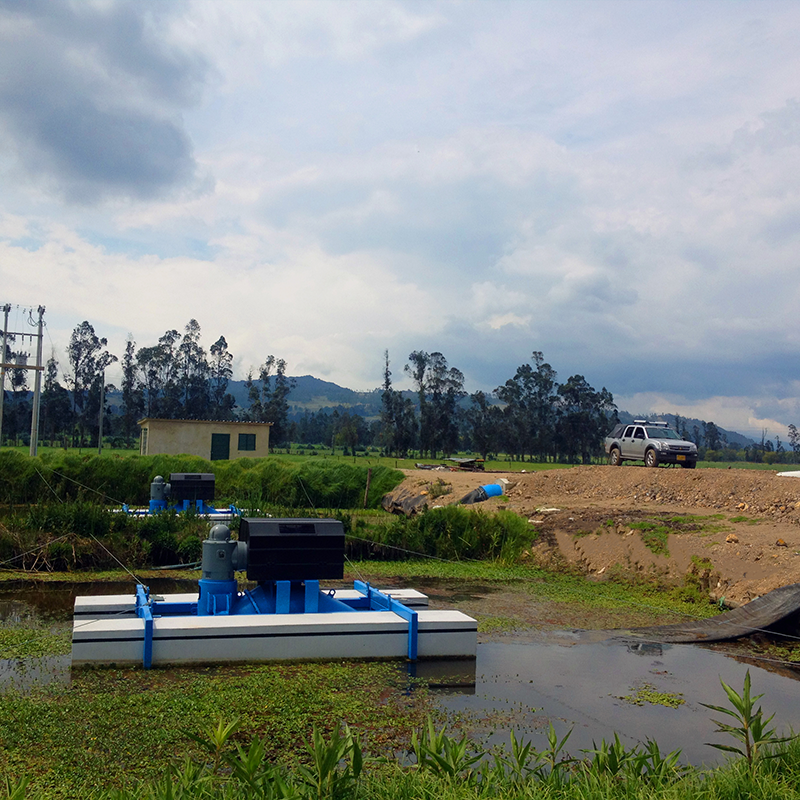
[0,0,800,442]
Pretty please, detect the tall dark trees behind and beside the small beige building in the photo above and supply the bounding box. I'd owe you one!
[3,319,294,447]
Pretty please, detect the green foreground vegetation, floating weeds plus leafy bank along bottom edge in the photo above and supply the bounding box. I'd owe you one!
[0,663,800,800]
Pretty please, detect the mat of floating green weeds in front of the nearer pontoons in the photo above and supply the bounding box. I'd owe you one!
[0,662,430,798]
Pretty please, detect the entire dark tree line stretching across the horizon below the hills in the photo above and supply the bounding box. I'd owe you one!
[12,319,784,463]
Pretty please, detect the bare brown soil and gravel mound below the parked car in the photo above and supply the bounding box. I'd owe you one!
[400,464,800,606]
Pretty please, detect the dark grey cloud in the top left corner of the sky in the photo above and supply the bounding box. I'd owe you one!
[0,2,207,203]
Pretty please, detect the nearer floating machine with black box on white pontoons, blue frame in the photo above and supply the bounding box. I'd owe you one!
[72,518,477,669]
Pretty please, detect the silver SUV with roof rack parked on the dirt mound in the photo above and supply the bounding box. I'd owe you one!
[605,419,697,469]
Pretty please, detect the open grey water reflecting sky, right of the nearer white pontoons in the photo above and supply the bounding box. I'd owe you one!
[439,634,800,766]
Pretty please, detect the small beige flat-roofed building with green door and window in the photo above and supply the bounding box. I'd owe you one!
[138,417,272,461]
